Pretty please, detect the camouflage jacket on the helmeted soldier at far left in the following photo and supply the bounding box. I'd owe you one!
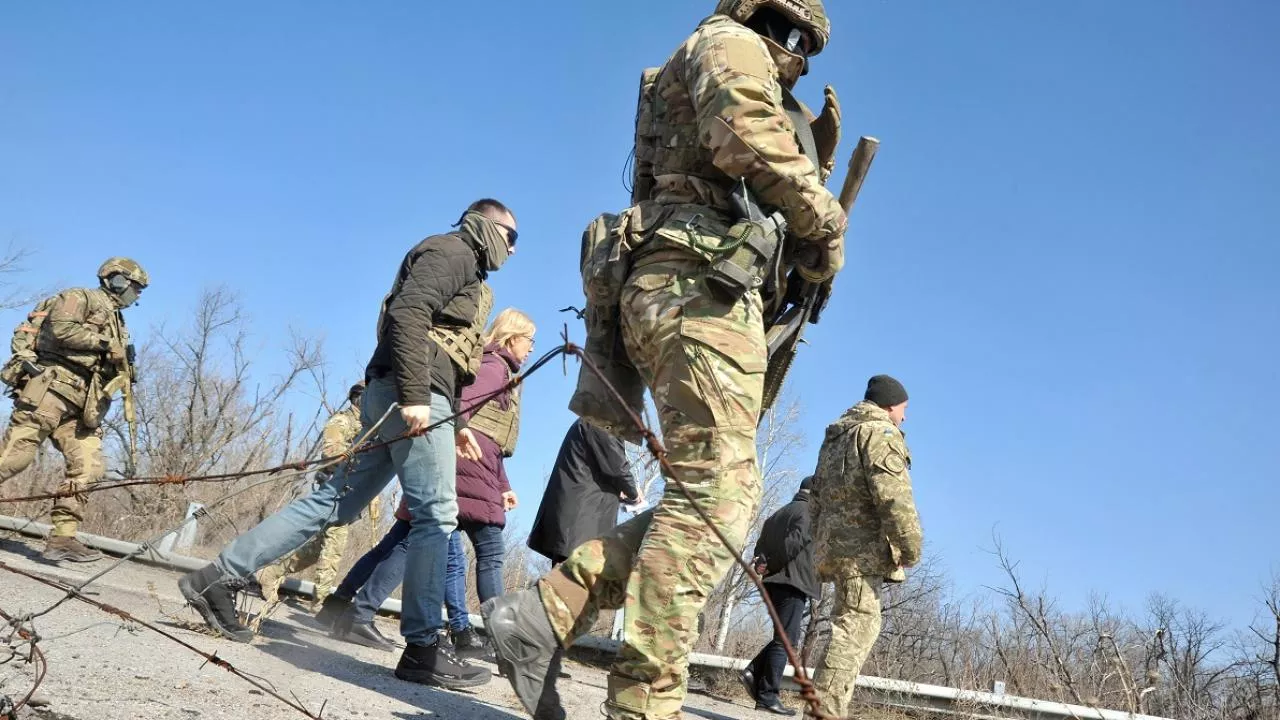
[36,287,129,384]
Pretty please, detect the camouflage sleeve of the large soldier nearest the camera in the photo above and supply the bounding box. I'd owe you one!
[685,27,849,240]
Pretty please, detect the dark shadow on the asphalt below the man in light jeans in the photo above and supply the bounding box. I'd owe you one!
[253,609,524,720]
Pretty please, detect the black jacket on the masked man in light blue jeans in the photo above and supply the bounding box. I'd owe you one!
[366,233,485,409]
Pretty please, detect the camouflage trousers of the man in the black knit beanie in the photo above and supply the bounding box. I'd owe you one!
[813,575,884,717]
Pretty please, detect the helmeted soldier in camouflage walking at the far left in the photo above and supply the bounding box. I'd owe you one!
[0,258,148,561]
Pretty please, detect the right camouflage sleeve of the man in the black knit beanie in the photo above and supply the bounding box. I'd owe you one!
[858,425,924,568]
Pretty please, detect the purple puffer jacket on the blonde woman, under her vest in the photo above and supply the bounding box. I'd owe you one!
[458,345,520,520]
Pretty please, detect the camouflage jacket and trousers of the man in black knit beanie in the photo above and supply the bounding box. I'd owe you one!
[813,401,923,717]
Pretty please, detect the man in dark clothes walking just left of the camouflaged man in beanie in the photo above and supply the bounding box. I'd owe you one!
[742,478,822,715]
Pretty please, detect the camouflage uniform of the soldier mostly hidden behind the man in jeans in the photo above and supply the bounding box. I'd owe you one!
[257,404,368,602]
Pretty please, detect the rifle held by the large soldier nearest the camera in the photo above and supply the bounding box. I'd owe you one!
[760,136,879,419]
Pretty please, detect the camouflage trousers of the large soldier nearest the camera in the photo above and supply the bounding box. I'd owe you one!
[539,254,765,720]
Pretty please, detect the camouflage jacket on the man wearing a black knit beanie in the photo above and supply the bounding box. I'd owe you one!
[813,402,924,579]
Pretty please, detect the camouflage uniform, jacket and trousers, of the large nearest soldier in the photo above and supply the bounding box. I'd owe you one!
[538,7,846,719]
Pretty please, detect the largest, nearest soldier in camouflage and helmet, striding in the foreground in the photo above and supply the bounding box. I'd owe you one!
[481,0,847,720]
